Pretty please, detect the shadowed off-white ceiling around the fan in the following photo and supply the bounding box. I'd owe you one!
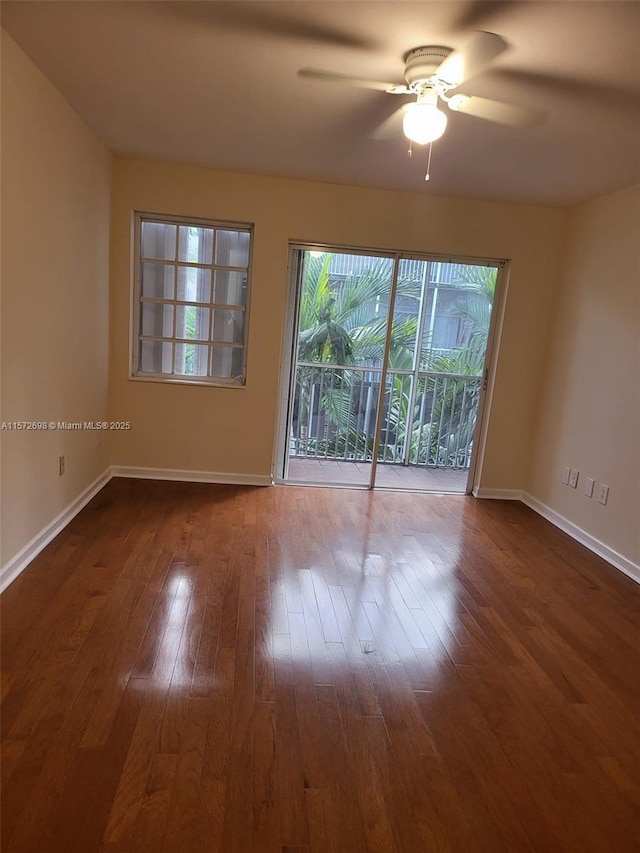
[2,0,640,205]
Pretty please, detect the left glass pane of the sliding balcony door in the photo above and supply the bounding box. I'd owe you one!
[285,249,394,487]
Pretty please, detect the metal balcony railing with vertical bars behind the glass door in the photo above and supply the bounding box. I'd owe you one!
[289,362,481,469]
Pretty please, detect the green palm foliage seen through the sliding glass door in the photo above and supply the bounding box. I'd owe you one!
[296,254,497,467]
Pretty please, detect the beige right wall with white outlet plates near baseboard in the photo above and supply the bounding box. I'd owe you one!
[530,187,640,564]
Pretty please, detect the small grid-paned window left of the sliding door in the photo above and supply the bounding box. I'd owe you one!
[132,214,252,385]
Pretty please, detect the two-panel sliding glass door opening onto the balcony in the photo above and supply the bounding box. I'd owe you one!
[277,247,498,492]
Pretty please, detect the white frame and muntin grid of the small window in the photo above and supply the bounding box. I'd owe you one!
[129,211,253,388]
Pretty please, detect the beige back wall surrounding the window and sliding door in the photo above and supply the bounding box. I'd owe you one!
[111,153,567,489]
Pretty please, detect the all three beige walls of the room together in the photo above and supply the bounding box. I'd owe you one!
[0,33,640,584]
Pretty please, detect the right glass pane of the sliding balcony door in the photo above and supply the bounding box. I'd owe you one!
[376,259,498,492]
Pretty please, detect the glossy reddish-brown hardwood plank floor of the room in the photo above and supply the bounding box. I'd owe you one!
[2,480,640,853]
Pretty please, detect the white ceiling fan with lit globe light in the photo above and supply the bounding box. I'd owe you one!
[298,32,537,145]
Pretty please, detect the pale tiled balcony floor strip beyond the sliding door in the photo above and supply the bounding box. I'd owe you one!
[287,456,469,494]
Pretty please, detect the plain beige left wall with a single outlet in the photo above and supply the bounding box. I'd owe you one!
[0,32,111,565]
